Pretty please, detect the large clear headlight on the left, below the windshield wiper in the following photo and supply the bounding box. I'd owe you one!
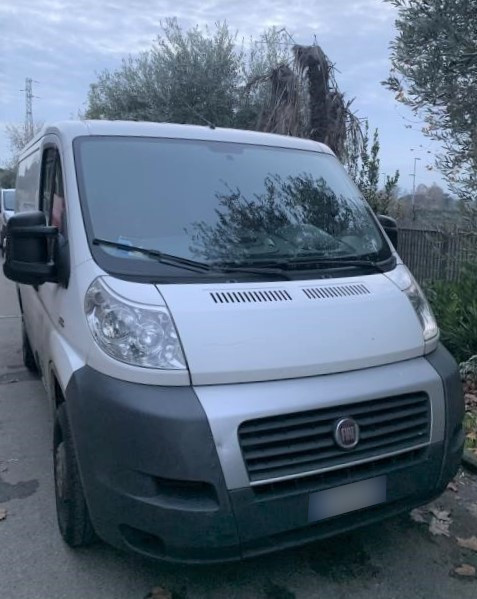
[85,278,186,370]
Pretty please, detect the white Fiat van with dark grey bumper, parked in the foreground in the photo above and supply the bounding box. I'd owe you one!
[4,121,463,562]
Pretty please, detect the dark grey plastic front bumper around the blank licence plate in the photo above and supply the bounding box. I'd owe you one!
[66,347,463,562]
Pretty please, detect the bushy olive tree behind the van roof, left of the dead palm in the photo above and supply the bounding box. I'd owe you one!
[85,19,242,126]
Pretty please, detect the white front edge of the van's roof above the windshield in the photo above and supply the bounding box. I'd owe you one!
[22,120,333,154]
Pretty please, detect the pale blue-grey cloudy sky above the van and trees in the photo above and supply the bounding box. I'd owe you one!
[0,0,441,188]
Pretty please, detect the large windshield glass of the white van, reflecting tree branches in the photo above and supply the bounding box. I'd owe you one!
[75,137,391,266]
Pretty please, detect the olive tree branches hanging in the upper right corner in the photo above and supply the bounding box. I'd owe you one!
[384,0,477,200]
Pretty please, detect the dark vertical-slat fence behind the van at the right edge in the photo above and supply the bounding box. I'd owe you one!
[398,229,477,283]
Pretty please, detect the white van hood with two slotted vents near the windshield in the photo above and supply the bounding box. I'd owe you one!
[157,274,424,385]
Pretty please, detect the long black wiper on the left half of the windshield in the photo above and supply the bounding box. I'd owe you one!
[92,237,290,280]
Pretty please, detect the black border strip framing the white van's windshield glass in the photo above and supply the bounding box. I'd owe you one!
[73,135,396,283]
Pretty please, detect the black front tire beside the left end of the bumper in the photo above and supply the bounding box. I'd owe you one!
[53,403,96,547]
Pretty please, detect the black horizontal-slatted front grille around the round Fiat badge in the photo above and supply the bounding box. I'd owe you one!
[238,393,431,483]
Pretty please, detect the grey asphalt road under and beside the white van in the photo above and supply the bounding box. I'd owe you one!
[0,275,477,599]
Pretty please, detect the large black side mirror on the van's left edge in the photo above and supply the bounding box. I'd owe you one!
[3,212,58,285]
